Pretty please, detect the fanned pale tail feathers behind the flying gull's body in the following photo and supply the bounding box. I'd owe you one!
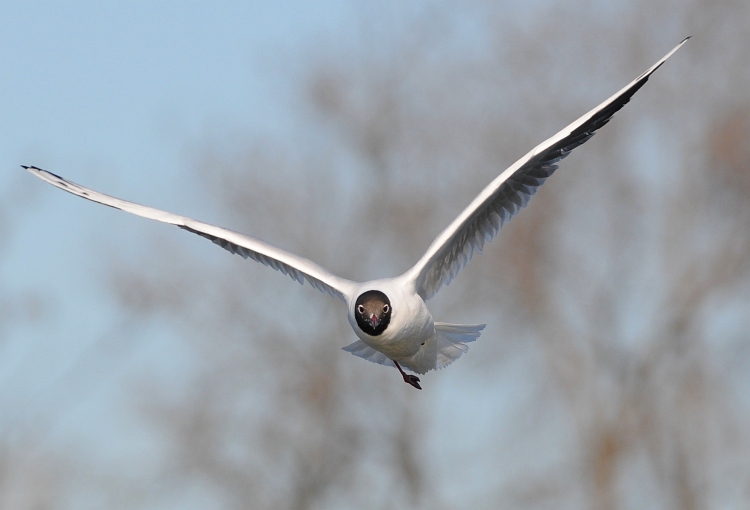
[343,322,485,374]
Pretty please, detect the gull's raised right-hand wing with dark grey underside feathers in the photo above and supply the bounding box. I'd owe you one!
[402,37,689,300]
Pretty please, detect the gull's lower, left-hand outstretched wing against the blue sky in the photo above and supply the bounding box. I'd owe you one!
[23,166,354,303]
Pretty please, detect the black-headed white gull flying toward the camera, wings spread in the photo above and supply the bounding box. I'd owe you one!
[22,37,689,390]
